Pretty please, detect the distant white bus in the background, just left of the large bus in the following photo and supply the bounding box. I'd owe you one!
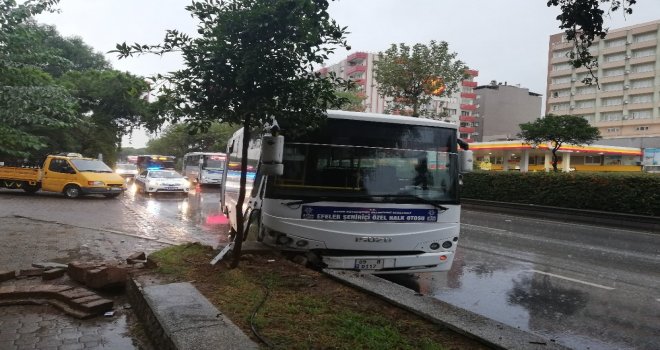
[183,152,227,185]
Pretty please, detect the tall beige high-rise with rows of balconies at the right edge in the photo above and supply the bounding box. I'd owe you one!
[546,20,660,139]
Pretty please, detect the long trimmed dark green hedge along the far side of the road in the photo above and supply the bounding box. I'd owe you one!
[462,172,660,216]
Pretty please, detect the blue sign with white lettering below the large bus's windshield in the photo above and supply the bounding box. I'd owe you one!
[301,205,438,222]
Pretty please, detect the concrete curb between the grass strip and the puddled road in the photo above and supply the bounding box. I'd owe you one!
[323,269,567,350]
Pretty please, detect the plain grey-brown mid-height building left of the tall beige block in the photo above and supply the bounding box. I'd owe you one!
[473,81,542,142]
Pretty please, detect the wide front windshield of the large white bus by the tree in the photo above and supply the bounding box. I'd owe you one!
[267,143,458,203]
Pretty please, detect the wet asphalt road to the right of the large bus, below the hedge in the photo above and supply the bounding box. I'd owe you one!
[386,211,660,349]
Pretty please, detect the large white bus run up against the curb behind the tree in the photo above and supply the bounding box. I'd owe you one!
[222,111,471,273]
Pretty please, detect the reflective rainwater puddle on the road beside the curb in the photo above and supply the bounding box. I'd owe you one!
[385,249,660,349]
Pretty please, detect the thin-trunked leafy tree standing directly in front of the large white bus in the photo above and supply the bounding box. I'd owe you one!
[116,0,347,267]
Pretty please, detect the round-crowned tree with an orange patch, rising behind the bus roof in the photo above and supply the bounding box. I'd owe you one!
[374,41,467,117]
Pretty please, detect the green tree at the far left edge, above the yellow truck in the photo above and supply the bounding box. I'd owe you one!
[0,0,78,158]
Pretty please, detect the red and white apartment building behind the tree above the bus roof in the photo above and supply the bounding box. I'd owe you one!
[319,52,479,142]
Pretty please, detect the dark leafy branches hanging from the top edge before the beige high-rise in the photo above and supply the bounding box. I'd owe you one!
[547,0,637,84]
